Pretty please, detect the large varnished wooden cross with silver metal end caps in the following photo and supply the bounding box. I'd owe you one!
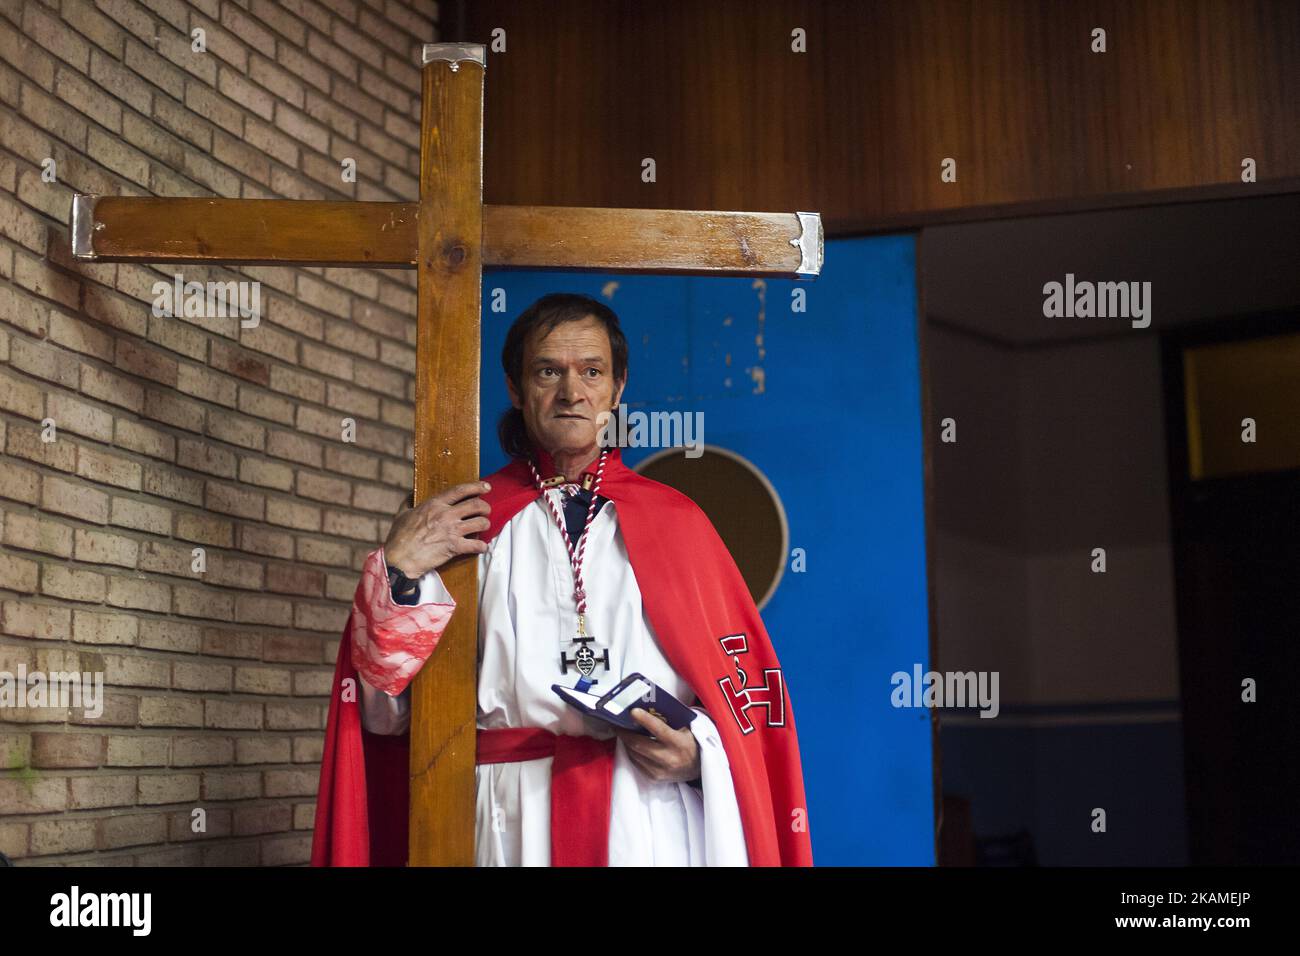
[72,43,822,865]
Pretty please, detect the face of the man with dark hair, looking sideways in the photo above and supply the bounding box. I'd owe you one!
[506,316,627,457]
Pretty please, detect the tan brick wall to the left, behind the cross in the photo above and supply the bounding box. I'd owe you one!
[0,0,437,865]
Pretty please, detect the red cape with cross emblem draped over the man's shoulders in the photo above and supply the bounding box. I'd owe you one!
[312,449,813,866]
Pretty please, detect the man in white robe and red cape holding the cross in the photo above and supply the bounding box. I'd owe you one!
[312,294,811,866]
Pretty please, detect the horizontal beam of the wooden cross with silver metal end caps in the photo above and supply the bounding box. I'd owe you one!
[72,195,822,278]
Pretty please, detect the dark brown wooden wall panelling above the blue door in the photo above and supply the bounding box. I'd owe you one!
[441,0,1300,234]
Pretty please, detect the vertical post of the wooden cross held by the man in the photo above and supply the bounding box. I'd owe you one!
[410,43,484,866]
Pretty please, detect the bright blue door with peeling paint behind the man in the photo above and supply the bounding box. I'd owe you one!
[482,235,935,866]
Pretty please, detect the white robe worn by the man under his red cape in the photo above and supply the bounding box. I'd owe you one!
[361,490,749,866]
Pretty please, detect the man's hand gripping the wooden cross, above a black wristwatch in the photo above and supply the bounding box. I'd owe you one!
[384,481,491,579]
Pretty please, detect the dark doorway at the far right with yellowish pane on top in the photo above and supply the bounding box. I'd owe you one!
[1164,313,1300,865]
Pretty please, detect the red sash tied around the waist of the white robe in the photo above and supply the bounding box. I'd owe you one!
[475,727,618,866]
